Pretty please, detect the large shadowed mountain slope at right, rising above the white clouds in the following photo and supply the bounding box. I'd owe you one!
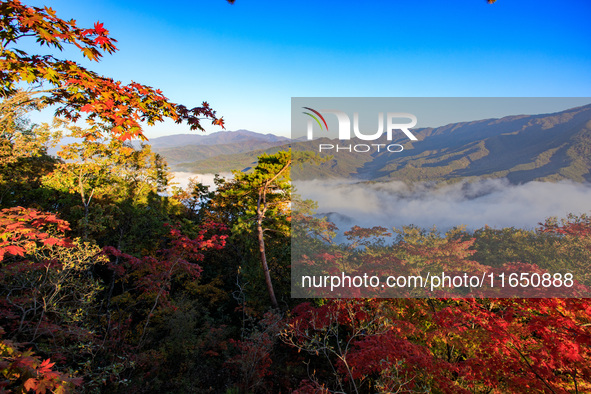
[358,105,591,183]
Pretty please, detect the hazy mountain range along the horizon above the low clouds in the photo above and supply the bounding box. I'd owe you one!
[151,104,591,183]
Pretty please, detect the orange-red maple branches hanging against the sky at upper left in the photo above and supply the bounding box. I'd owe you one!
[0,0,224,140]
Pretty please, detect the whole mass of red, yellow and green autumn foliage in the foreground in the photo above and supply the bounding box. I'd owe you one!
[0,0,591,394]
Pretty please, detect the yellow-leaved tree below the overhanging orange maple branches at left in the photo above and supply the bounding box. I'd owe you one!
[42,123,177,248]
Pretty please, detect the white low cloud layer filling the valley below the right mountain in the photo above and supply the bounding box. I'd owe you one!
[294,179,591,231]
